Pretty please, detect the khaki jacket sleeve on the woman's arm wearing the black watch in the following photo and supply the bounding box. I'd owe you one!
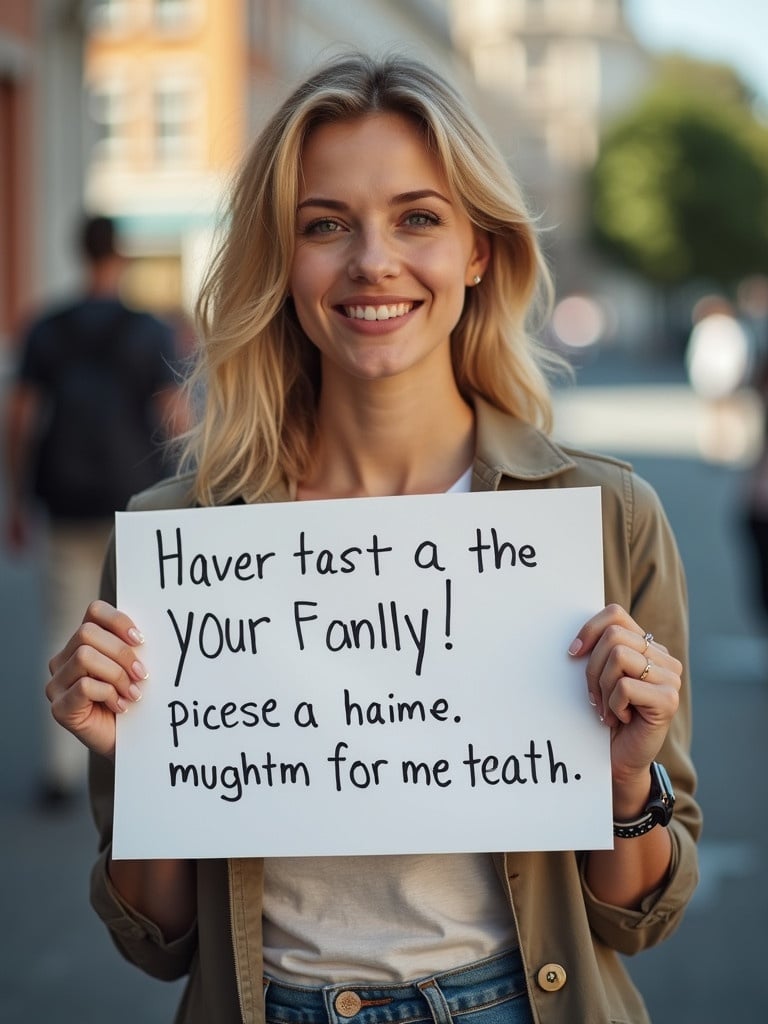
[581,469,701,954]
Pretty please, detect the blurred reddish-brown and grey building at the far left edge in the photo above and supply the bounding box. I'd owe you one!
[0,0,84,359]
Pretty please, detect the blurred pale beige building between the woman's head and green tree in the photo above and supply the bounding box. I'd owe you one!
[450,0,652,292]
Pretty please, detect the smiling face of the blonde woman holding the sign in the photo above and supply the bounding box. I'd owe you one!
[290,114,489,385]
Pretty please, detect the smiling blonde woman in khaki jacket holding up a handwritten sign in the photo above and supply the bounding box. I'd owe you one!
[47,55,700,1024]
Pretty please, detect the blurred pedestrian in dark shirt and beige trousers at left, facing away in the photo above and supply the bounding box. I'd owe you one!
[5,216,183,807]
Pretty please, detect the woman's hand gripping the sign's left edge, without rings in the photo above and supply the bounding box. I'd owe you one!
[45,601,146,759]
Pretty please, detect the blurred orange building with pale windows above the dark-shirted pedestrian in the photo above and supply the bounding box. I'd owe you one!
[84,0,249,312]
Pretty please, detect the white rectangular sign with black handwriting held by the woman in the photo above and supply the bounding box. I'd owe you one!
[114,488,612,858]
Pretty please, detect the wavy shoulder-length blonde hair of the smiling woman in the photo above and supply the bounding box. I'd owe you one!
[184,54,551,505]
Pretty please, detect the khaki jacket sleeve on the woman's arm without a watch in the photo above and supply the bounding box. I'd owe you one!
[89,516,198,981]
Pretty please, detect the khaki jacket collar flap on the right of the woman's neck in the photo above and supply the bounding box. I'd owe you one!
[474,395,575,489]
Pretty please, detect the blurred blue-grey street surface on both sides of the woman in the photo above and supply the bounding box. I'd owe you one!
[0,356,768,1024]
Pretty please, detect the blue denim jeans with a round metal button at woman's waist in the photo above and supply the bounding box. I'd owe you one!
[264,950,534,1024]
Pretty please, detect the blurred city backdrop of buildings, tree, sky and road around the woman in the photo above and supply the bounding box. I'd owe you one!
[0,0,768,1024]
